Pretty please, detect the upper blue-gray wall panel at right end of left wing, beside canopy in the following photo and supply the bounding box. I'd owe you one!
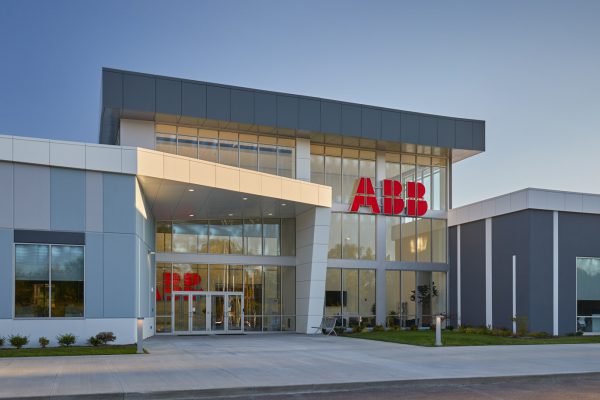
[102,174,135,233]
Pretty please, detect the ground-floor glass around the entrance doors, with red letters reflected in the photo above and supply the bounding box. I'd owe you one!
[156,263,296,333]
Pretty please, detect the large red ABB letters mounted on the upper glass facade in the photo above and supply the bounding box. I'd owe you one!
[350,178,427,217]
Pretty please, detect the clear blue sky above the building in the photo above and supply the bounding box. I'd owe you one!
[0,0,600,206]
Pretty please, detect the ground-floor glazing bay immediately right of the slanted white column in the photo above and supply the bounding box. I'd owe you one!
[325,268,376,327]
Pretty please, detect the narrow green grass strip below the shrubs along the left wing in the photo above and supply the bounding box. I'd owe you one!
[0,344,137,358]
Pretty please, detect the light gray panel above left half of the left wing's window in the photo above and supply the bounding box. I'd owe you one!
[14,164,50,230]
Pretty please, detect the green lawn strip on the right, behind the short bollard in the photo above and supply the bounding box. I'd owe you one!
[344,331,600,346]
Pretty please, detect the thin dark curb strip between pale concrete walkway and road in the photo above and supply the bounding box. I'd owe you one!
[11,372,600,400]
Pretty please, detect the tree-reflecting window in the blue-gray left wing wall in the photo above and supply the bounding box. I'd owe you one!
[15,244,84,318]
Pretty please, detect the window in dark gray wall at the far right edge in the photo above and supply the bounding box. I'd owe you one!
[576,257,600,333]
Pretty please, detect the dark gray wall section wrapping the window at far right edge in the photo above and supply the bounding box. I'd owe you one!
[558,212,600,335]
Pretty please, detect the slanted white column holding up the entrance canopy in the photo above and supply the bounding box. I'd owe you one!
[296,207,331,333]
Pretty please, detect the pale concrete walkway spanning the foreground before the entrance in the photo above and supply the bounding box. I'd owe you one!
[0,334,600,398]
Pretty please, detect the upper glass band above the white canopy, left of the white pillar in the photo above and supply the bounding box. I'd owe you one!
[155,124,296,178]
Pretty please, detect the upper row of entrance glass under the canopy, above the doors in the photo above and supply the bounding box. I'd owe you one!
[156,218,296,256]
